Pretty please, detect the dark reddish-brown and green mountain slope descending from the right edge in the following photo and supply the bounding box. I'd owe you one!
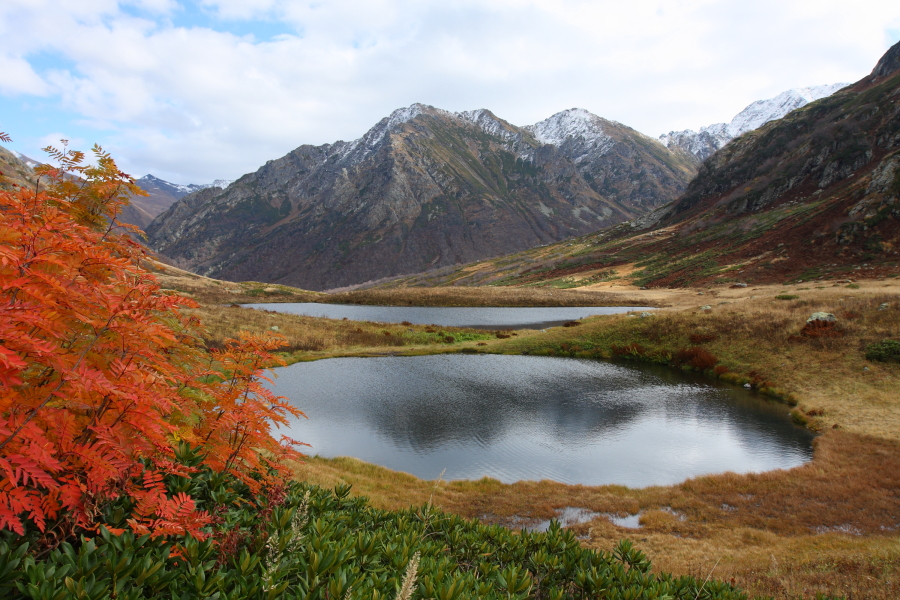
[372,43,900,288]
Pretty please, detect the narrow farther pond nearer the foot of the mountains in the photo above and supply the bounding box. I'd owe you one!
[242,302,653,329]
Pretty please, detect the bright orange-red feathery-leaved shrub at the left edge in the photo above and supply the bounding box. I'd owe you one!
[0,146,301,539]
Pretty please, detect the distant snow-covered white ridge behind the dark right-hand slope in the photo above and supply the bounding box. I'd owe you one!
[659,83,849,162]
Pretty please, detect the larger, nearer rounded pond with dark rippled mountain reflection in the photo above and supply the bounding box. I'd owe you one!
[275,354,813,487]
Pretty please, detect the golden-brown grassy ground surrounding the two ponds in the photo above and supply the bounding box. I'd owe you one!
[156,264,900,599]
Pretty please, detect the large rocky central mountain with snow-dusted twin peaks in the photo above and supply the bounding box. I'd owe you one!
[147,104,694,289]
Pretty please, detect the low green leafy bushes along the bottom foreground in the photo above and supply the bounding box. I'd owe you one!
[0,448,760,600]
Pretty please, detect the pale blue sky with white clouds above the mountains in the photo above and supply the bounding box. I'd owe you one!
[0,0,900,184]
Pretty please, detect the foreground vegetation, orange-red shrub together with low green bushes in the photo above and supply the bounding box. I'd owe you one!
[0,146,768,600]
